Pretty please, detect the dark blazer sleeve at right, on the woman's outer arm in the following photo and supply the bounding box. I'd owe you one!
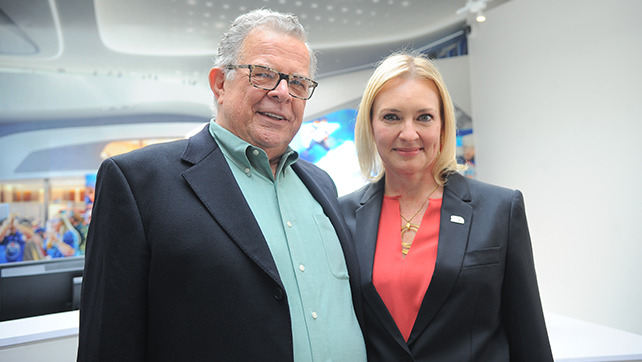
[502,191,553,362]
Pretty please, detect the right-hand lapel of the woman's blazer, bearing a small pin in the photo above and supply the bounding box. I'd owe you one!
[408,173,473,344]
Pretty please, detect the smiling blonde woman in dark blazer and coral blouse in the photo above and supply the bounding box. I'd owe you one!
[340,54,552,362]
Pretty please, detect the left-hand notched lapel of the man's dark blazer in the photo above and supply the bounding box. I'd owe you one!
[182,126,282,285]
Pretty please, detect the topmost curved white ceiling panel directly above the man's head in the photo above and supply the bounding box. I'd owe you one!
[95,0,470,55]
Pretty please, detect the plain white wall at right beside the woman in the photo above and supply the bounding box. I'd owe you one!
[469,0,642,334]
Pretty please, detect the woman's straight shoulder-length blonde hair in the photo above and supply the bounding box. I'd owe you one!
[354,52,465,185]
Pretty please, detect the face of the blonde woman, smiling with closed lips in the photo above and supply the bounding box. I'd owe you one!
[372,78,442,181]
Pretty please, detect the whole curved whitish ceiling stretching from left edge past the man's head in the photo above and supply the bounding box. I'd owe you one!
[0,0,507,129]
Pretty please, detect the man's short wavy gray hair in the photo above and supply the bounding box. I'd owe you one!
[214,9,317,79]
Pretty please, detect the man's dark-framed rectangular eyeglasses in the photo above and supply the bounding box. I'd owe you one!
[225,64,319,100]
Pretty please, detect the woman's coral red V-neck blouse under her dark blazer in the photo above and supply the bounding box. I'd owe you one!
[372,195,442,341]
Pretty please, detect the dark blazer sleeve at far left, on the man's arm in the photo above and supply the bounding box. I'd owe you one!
[78,159,149,361]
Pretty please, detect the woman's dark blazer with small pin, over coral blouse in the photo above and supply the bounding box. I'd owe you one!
[339,173,553,362]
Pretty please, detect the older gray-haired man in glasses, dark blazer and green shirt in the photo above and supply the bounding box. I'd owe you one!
[78,10,365,361]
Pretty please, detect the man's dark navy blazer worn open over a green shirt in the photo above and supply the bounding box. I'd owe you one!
[78,127,360,362]
